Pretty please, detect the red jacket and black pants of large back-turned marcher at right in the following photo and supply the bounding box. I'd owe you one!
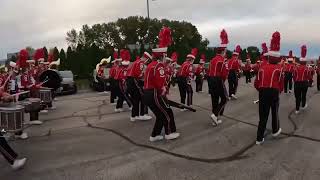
[254,64,284,141]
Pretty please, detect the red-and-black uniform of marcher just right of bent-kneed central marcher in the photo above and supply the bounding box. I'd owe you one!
[178,61,193,106]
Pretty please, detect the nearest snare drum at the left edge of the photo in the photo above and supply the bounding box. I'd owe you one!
[0,105,24,131]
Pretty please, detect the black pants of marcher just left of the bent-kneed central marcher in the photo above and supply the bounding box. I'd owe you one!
[127,77,148,117]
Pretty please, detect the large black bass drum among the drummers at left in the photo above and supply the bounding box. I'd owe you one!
[39,69,62,90]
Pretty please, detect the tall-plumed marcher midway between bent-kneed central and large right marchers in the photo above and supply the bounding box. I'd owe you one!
[208,29,229,126]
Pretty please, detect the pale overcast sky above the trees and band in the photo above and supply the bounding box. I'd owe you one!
[0,0,320,59]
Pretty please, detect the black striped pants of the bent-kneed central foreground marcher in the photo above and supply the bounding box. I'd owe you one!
[144,89,176,137]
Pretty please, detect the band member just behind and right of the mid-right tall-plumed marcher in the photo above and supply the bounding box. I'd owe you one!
[228,45,241,99]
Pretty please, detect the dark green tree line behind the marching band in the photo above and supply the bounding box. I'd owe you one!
[9,16,260,78]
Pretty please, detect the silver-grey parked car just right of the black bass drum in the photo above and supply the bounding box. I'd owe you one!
[57,71,77,94]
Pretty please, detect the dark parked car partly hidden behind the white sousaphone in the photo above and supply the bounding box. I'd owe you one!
[90,67,110,92]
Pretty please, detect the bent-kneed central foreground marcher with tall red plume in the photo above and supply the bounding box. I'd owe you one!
[144,27,180,142]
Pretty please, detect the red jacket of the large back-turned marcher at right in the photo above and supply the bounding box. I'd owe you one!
[254,64,284,92]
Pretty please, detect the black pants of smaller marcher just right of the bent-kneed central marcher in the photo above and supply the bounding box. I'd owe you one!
[178,77,193,106]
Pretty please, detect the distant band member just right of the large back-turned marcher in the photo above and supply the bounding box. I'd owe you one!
[284,51,294,94]
